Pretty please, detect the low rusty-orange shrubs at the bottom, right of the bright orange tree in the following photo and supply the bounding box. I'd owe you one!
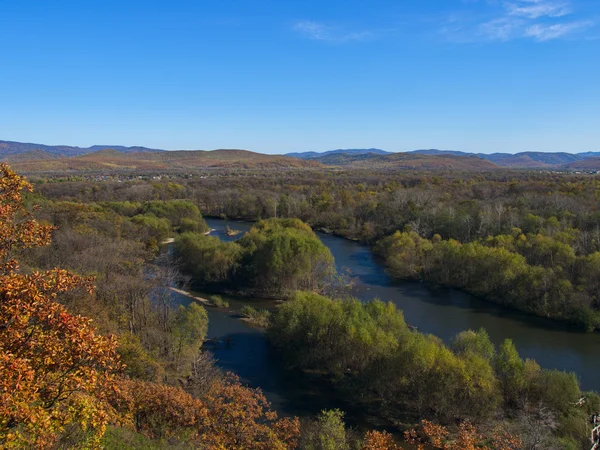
[111,377,300,450]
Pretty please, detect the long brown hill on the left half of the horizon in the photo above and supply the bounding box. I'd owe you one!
[5,149,323,173]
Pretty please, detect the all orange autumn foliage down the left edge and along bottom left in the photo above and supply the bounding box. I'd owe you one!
[0,165,299,450]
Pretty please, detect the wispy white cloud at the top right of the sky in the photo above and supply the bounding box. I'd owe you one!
[440,0,596,42]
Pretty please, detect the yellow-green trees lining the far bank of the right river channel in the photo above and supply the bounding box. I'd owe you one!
[376,230,600,331]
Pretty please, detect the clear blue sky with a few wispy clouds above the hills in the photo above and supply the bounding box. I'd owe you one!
[0,0,600,153]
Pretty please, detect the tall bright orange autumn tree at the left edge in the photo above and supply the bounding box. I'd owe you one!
[0,164,119,448]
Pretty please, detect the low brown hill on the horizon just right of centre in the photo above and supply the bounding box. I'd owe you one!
[312,152,498,170]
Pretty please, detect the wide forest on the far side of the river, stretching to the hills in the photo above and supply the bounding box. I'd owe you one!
[34,170,600,330]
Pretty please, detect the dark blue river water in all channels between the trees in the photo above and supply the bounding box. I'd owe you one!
[169,219,600,416]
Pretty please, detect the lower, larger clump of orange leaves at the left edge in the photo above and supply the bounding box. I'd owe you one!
[0,273,119,448]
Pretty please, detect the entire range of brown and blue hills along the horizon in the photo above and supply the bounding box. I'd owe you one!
[0,141,600,173]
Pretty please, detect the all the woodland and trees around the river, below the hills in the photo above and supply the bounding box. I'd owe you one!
[0,166,600,449]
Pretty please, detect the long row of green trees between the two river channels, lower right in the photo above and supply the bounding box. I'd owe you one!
[268,292,593,442]
